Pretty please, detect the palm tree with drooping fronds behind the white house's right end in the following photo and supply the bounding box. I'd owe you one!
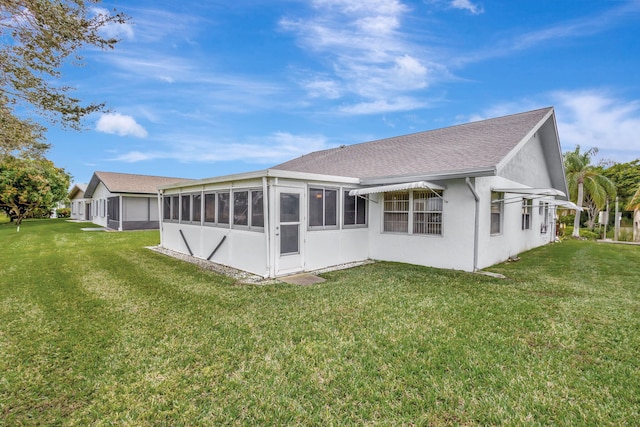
[564,145,616,237]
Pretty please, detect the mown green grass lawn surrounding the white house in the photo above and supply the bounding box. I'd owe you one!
[0,220,640,426]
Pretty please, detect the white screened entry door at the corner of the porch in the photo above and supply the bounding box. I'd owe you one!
[275,188,304,276]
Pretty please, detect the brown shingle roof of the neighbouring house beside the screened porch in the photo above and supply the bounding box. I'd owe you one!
[85,172,191,197]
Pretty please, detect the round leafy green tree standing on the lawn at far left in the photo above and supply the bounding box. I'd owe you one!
[0,156,71,231]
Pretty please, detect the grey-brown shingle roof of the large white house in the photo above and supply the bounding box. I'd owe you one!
[273,107,553,178]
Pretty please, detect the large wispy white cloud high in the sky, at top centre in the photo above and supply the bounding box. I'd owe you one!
[280,0,442,114]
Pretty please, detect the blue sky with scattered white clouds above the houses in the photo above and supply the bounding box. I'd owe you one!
[48,0,640,182]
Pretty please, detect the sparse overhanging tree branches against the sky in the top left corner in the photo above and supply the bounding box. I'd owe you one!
[0,0,127,132]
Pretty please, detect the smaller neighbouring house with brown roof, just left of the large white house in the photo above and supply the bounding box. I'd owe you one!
[84,172,192,231]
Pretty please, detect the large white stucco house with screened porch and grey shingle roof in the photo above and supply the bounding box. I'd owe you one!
[159,107,568,277]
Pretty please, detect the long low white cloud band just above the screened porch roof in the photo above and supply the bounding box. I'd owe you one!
[111,132,330,165]
